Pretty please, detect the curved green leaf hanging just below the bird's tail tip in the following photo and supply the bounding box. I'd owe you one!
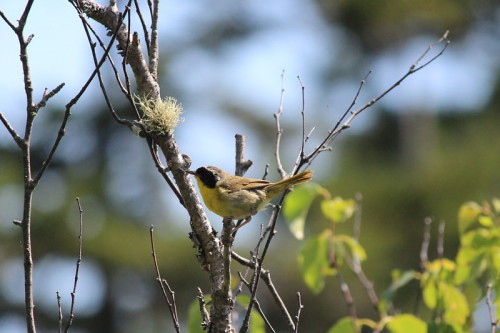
[283,183,327,239]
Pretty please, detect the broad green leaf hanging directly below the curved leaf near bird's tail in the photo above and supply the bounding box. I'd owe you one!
[298,230,336,294]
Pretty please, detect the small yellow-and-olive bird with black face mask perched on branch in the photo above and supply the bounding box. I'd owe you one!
[186,166,312,228]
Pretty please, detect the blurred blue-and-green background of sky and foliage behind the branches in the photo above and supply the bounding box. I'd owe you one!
[0,0,500,332]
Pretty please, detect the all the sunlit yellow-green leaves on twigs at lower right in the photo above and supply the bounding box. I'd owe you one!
[283,184,500,333]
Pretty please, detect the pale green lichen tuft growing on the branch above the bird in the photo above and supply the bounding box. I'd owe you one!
[135,96,184,135]
